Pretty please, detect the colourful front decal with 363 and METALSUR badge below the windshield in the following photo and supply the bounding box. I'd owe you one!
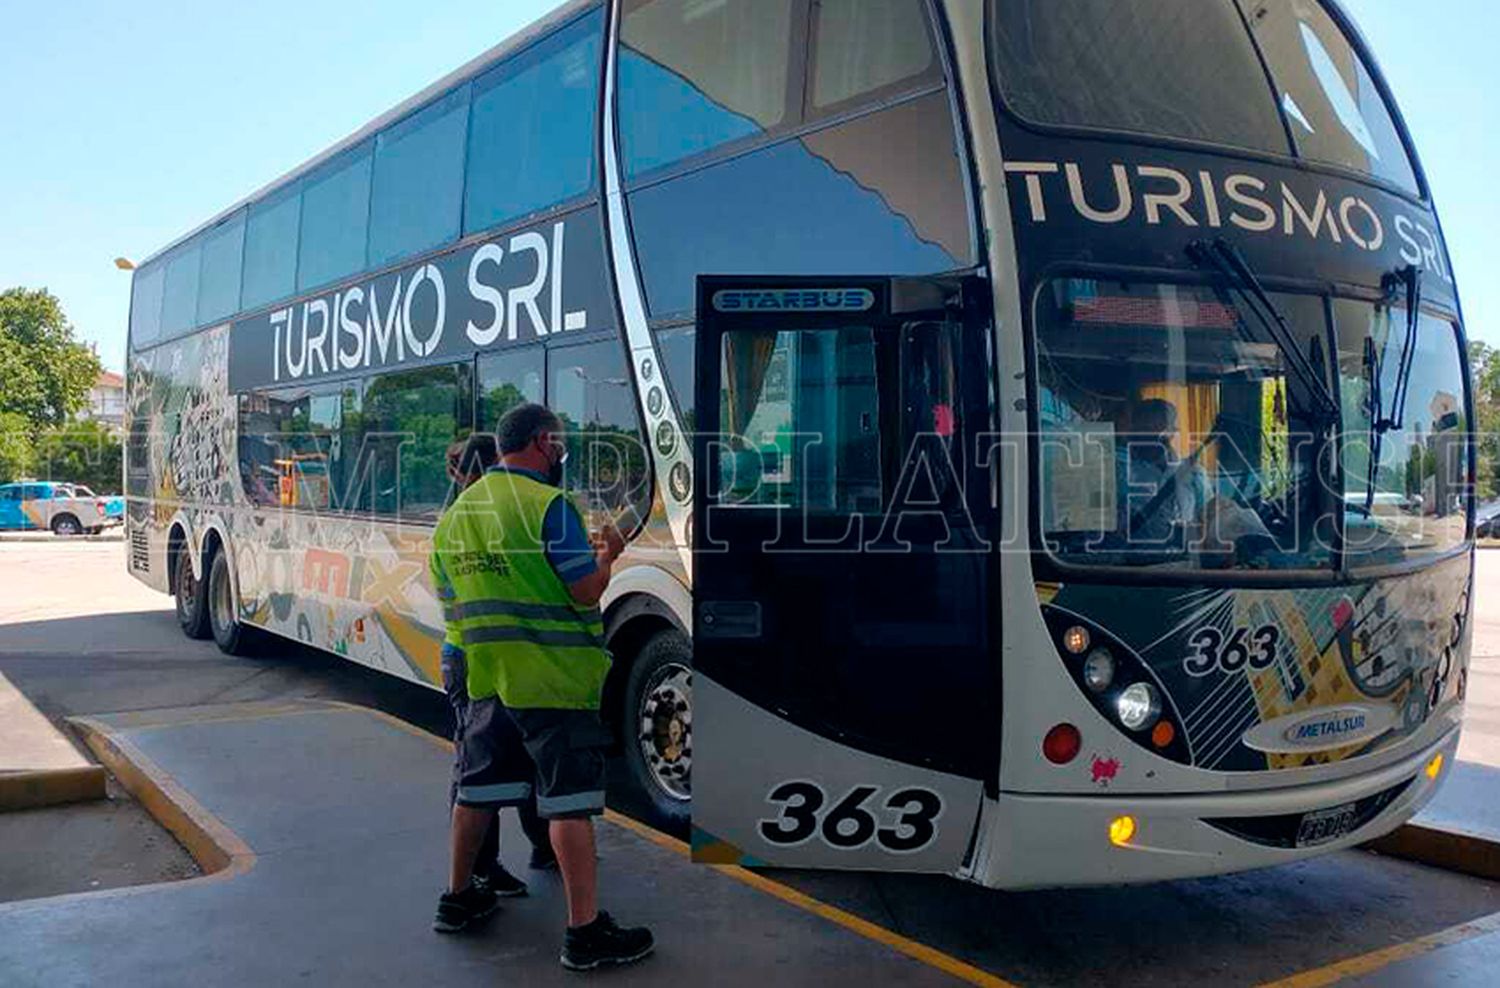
[1037,556,1470,784]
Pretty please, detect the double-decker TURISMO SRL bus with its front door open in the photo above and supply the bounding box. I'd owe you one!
[126,0,1473,888]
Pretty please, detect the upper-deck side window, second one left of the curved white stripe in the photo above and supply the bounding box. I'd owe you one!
[369,85,468,267]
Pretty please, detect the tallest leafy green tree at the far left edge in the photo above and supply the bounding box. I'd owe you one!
[0,288,101,430]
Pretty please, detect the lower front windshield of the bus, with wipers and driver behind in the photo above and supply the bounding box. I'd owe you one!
[1037,279,1469,571]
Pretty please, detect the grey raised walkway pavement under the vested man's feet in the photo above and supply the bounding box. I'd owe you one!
[0,702,956,988]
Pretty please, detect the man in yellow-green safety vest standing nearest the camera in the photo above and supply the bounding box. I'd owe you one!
[432,405,654,970]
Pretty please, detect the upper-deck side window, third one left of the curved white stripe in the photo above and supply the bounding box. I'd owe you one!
[297,144,371,291]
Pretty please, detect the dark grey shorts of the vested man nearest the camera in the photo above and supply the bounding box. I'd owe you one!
[504,708,614,820]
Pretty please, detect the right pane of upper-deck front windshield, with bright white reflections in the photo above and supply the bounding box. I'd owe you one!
[1245,0,1418,193]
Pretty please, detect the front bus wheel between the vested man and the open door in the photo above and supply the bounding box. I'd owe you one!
[620,628,693,825]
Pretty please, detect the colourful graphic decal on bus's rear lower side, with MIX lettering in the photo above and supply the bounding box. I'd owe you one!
[126,328,443,684]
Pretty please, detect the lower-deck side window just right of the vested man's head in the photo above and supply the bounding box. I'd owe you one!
[548,339,651,525]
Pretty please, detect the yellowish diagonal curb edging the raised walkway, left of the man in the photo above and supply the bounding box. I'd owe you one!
[68,717,255,877]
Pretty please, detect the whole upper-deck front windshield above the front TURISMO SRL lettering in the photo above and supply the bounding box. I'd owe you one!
[990,0,1419,195]
